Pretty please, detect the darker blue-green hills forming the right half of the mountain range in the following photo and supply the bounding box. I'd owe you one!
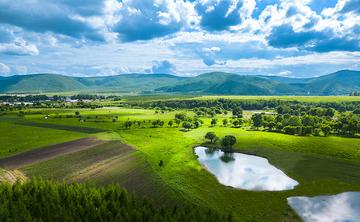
[157,70,360,95]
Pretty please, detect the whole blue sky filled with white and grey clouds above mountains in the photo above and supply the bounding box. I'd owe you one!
[0,0,360,78]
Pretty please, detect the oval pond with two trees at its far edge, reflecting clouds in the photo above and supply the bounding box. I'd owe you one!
[195,146,298,191]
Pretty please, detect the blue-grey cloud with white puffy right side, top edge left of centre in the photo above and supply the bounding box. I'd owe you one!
[113,0,197,41]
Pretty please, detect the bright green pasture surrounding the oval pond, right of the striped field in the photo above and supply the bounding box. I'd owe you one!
[118,127,360,221]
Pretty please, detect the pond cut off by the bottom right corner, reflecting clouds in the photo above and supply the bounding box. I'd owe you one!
[287,192,360,222]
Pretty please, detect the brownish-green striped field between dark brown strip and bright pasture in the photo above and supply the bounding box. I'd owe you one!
[20,141,181,206]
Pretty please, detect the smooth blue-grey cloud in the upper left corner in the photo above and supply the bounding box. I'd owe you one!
[0,0,104,41]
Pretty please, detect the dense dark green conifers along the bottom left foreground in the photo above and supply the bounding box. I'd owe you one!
[0,179,232,222]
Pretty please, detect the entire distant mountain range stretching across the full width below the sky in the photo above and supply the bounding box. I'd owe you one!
[0,70,360,95]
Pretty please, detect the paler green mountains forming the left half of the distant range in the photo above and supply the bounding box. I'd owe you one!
[0,74,183,93]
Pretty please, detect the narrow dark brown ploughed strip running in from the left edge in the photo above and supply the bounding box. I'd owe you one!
[0,138,106,169]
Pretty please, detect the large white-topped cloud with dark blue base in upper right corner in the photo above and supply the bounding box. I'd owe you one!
[259,1,360,52]
